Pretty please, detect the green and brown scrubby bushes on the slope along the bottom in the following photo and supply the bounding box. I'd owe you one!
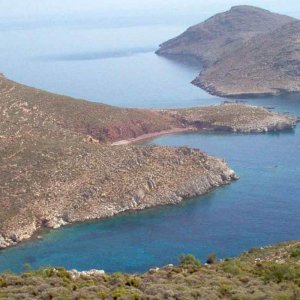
[0,242,300,299]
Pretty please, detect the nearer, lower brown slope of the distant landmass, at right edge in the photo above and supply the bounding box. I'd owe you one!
[193,21,300,97]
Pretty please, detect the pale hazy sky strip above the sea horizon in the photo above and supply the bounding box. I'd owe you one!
[0,0,300,21]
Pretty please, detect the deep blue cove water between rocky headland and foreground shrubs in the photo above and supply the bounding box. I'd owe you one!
[0,95,300,272]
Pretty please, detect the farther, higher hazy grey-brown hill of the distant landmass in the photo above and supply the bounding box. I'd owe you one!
[157,5,295,66]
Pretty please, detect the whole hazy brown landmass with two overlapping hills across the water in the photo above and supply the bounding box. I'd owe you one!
[157,5,300,98]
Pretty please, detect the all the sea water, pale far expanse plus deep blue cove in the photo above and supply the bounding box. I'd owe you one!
[0,0,300,272]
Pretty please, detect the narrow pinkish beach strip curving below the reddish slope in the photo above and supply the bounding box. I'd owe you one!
[111,127,199,146]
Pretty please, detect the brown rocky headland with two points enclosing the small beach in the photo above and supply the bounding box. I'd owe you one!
[0,75,297,248]
